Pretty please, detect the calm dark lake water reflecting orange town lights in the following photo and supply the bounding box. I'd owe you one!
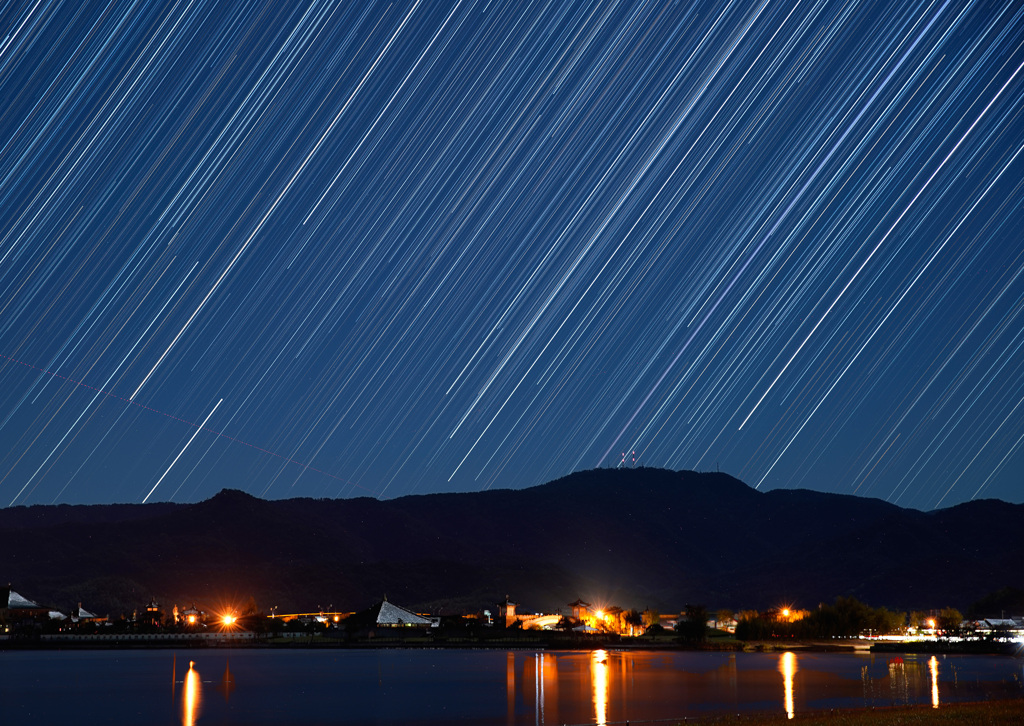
[0,649,1024,726]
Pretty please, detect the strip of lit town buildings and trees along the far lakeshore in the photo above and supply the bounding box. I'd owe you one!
[8,586,1024,647]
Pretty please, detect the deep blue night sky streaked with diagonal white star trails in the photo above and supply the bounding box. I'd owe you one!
[0,0,1024,509]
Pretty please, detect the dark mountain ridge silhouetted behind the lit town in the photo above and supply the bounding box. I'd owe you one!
[0,468,1024,612]
